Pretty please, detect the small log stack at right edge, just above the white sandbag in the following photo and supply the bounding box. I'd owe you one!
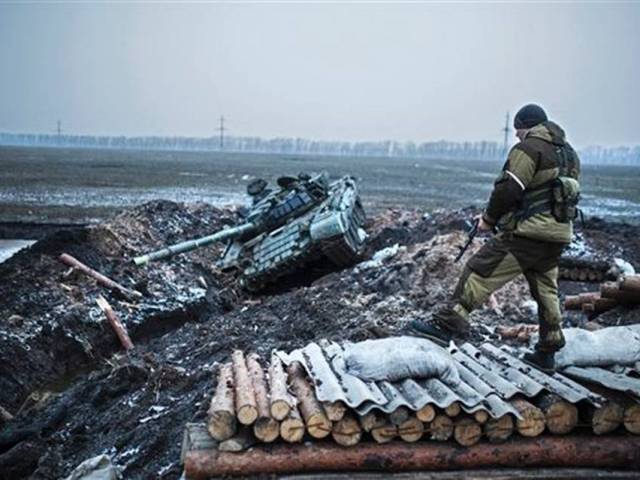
[564,275,640,316]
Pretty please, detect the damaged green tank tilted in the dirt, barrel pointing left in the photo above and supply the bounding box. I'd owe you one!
[134,172,367,291]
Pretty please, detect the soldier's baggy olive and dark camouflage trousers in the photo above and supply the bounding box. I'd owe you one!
[434,233,565,352]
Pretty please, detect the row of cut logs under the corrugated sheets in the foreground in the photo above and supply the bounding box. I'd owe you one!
[207,350,640,451]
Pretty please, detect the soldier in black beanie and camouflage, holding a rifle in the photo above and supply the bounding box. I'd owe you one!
[409,104,580,371]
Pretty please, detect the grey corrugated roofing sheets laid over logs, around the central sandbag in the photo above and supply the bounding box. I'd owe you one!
[278,341,604,418]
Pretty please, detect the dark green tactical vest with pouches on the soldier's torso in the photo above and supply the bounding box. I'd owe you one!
[514,137,580,223]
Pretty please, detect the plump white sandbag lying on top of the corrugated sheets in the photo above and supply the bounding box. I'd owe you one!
[344,337,460,385]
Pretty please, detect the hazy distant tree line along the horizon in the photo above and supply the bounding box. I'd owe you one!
[0,133,640,165]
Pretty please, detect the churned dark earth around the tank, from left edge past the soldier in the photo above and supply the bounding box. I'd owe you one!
[0,202,640,479]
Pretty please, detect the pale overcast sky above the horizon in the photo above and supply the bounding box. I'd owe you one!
[0,2,640,146]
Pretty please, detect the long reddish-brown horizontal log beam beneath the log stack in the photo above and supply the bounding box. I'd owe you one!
[185,435,640,480]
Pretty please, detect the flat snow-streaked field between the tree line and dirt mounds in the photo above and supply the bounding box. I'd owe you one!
[0,147,640,223]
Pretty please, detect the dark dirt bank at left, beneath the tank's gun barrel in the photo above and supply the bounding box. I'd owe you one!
[0,202,234,410]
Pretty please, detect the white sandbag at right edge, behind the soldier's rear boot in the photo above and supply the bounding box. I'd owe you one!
[556,325,640,368]
